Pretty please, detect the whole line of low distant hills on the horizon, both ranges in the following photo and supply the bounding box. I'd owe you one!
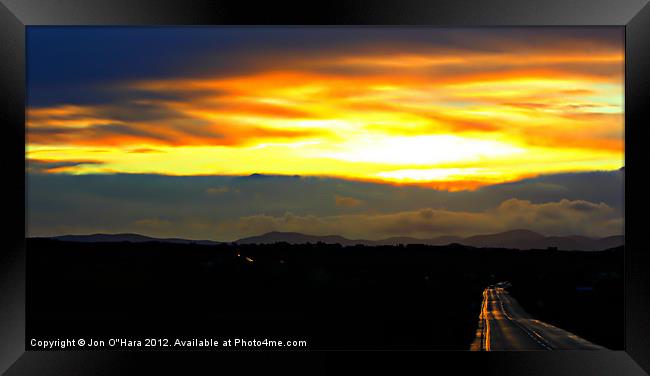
[36,230,625,251]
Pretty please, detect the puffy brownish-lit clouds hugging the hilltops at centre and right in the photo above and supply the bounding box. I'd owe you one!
[217,199,623,240]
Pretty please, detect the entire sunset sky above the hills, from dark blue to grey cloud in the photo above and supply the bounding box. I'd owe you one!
[26,27,624,240]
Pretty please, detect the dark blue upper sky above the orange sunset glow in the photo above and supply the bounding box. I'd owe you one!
[26,26,623,106]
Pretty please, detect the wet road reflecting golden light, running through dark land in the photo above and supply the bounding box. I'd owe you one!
[471,287,605,351]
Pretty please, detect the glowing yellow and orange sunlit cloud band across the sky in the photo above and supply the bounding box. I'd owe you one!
[27,32,624,190]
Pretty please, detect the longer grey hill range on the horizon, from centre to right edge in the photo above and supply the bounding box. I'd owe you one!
[235,230,625,251]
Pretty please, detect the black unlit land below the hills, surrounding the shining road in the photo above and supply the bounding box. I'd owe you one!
[27,239,624,350]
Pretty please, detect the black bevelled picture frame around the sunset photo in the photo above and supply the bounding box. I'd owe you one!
[0,0,650,375]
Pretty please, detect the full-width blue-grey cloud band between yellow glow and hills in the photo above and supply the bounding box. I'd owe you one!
[27,171,624,240]
